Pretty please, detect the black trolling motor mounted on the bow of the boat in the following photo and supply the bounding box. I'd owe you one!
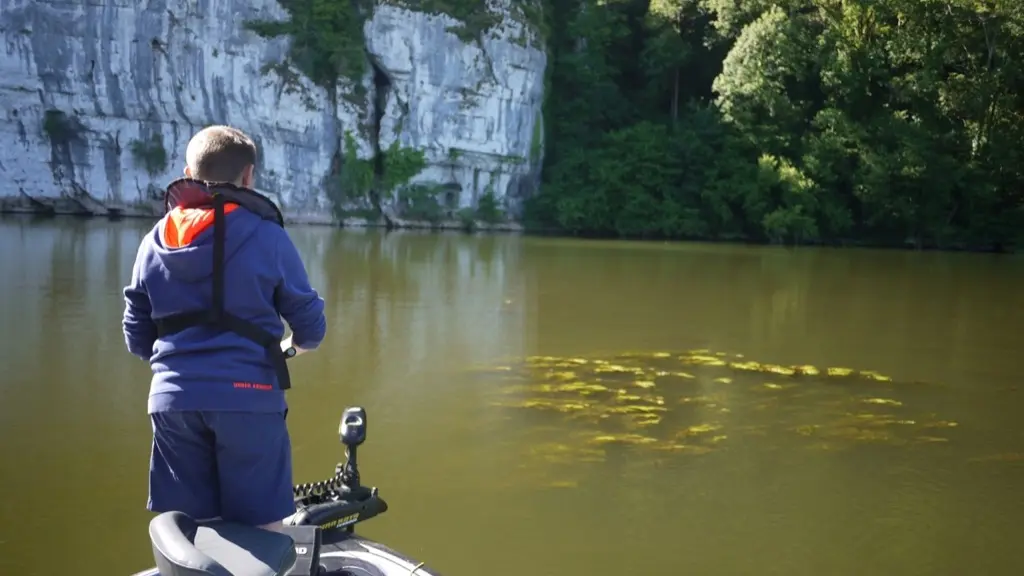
[289,406,387,534]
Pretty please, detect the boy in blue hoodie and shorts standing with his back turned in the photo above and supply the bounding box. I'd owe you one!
[123,126,327,530]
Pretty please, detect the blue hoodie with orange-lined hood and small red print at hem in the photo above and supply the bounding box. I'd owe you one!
[123,204,327,414]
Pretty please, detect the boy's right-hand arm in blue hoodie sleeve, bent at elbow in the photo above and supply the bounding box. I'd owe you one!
[276,231,327,354]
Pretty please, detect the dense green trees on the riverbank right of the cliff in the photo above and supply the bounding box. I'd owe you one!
[526,0,1024,249]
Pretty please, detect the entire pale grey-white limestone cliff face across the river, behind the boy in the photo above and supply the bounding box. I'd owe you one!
[0,0,547,222]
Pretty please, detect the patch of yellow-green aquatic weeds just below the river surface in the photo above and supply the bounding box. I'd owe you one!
[475,349,956,462]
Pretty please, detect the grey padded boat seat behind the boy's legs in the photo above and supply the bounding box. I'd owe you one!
[150,511,295,576]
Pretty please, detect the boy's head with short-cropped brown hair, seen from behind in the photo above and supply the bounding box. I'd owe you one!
[185,126,256,188]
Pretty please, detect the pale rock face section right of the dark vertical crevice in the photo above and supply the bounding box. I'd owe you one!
[365,6,547,223]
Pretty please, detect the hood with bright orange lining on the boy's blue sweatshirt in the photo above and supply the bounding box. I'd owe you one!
[151,203,263,283]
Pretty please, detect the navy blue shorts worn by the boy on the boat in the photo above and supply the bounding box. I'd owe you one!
[147,411,295,525]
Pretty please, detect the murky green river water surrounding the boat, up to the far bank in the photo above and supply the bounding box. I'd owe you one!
[0,217,1024,576]
